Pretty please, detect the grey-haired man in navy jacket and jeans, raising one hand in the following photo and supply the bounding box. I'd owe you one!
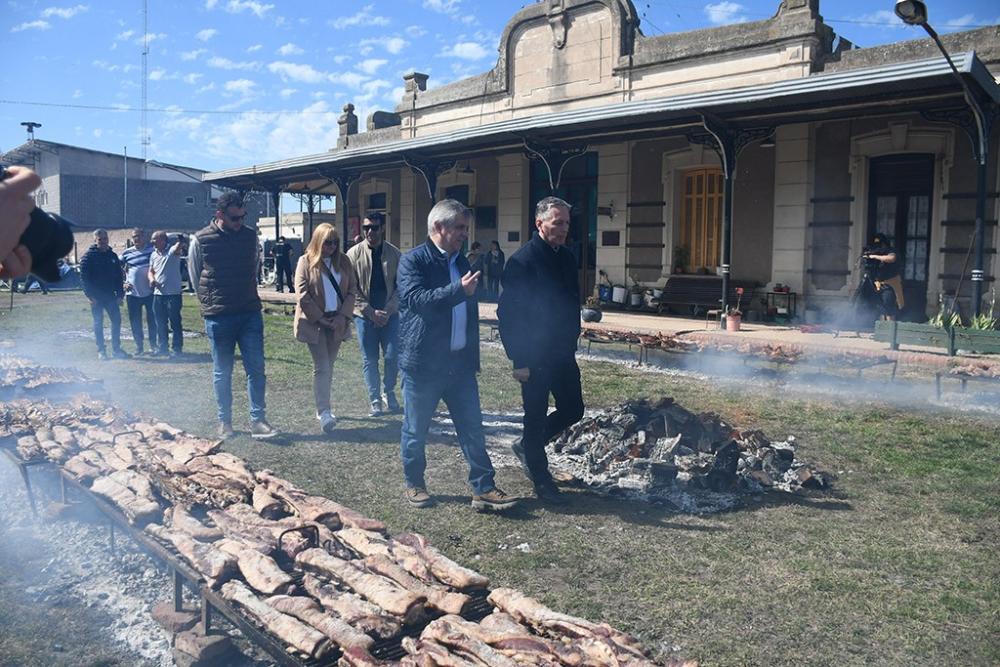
[396,199,516,510]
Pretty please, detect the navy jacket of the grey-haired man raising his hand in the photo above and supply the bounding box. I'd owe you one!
[396,239,479,375]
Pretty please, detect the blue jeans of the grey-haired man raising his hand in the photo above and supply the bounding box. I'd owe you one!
[399,370,496,495]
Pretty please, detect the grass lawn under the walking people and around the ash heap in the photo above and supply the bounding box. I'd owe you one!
[0,293,1000,665]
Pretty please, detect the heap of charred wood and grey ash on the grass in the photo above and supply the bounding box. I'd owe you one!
[550,398,828,511]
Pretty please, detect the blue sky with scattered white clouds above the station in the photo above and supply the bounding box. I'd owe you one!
[0,0,1000,170]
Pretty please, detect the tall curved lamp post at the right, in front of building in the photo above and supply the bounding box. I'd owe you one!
[895,0,990,316]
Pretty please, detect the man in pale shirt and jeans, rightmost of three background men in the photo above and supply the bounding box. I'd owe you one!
[148,230,186,358]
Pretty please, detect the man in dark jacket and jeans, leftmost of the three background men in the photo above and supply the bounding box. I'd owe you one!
[80,229,129,359]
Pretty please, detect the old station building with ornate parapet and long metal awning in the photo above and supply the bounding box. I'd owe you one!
[206,0,1000,318]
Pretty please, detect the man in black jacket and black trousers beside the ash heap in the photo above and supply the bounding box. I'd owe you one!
[497,197,583,504]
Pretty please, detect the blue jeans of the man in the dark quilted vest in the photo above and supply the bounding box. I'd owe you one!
[205,310,266,424]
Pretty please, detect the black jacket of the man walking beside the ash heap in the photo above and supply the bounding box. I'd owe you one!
[497,234,580,368]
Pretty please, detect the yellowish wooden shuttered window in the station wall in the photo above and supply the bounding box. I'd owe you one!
[680,168,722,273]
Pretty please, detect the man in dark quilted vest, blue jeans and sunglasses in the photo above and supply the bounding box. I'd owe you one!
[188,192,278,439]
